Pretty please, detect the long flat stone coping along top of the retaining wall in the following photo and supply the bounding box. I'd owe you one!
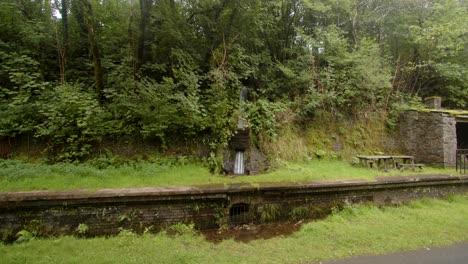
[0,175,468,208]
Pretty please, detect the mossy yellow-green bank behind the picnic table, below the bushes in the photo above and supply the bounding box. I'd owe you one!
[259,112,398,161]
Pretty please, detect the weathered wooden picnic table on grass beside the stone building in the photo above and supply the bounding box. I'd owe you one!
[356,155,415,170]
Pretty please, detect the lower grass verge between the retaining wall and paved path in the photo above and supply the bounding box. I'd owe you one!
[0,195,468,263]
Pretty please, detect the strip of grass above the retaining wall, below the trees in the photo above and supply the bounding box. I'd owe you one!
[0,160,455,191]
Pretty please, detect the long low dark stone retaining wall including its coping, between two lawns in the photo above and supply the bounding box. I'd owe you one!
[0,175,468,241]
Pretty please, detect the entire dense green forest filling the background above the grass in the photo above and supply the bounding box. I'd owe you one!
[0,0,468,164]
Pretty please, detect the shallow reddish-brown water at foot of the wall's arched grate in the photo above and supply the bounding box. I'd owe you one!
[201,221,302,243]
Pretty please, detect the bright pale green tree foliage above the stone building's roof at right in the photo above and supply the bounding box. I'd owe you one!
[388,0,468,108]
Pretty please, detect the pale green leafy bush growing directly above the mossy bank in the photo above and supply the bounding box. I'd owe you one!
[305,30,391,113]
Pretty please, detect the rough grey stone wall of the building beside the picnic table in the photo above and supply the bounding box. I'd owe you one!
[400,111,457,166]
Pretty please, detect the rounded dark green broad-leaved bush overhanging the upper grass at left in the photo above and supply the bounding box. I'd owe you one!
[35,85,109,161]
